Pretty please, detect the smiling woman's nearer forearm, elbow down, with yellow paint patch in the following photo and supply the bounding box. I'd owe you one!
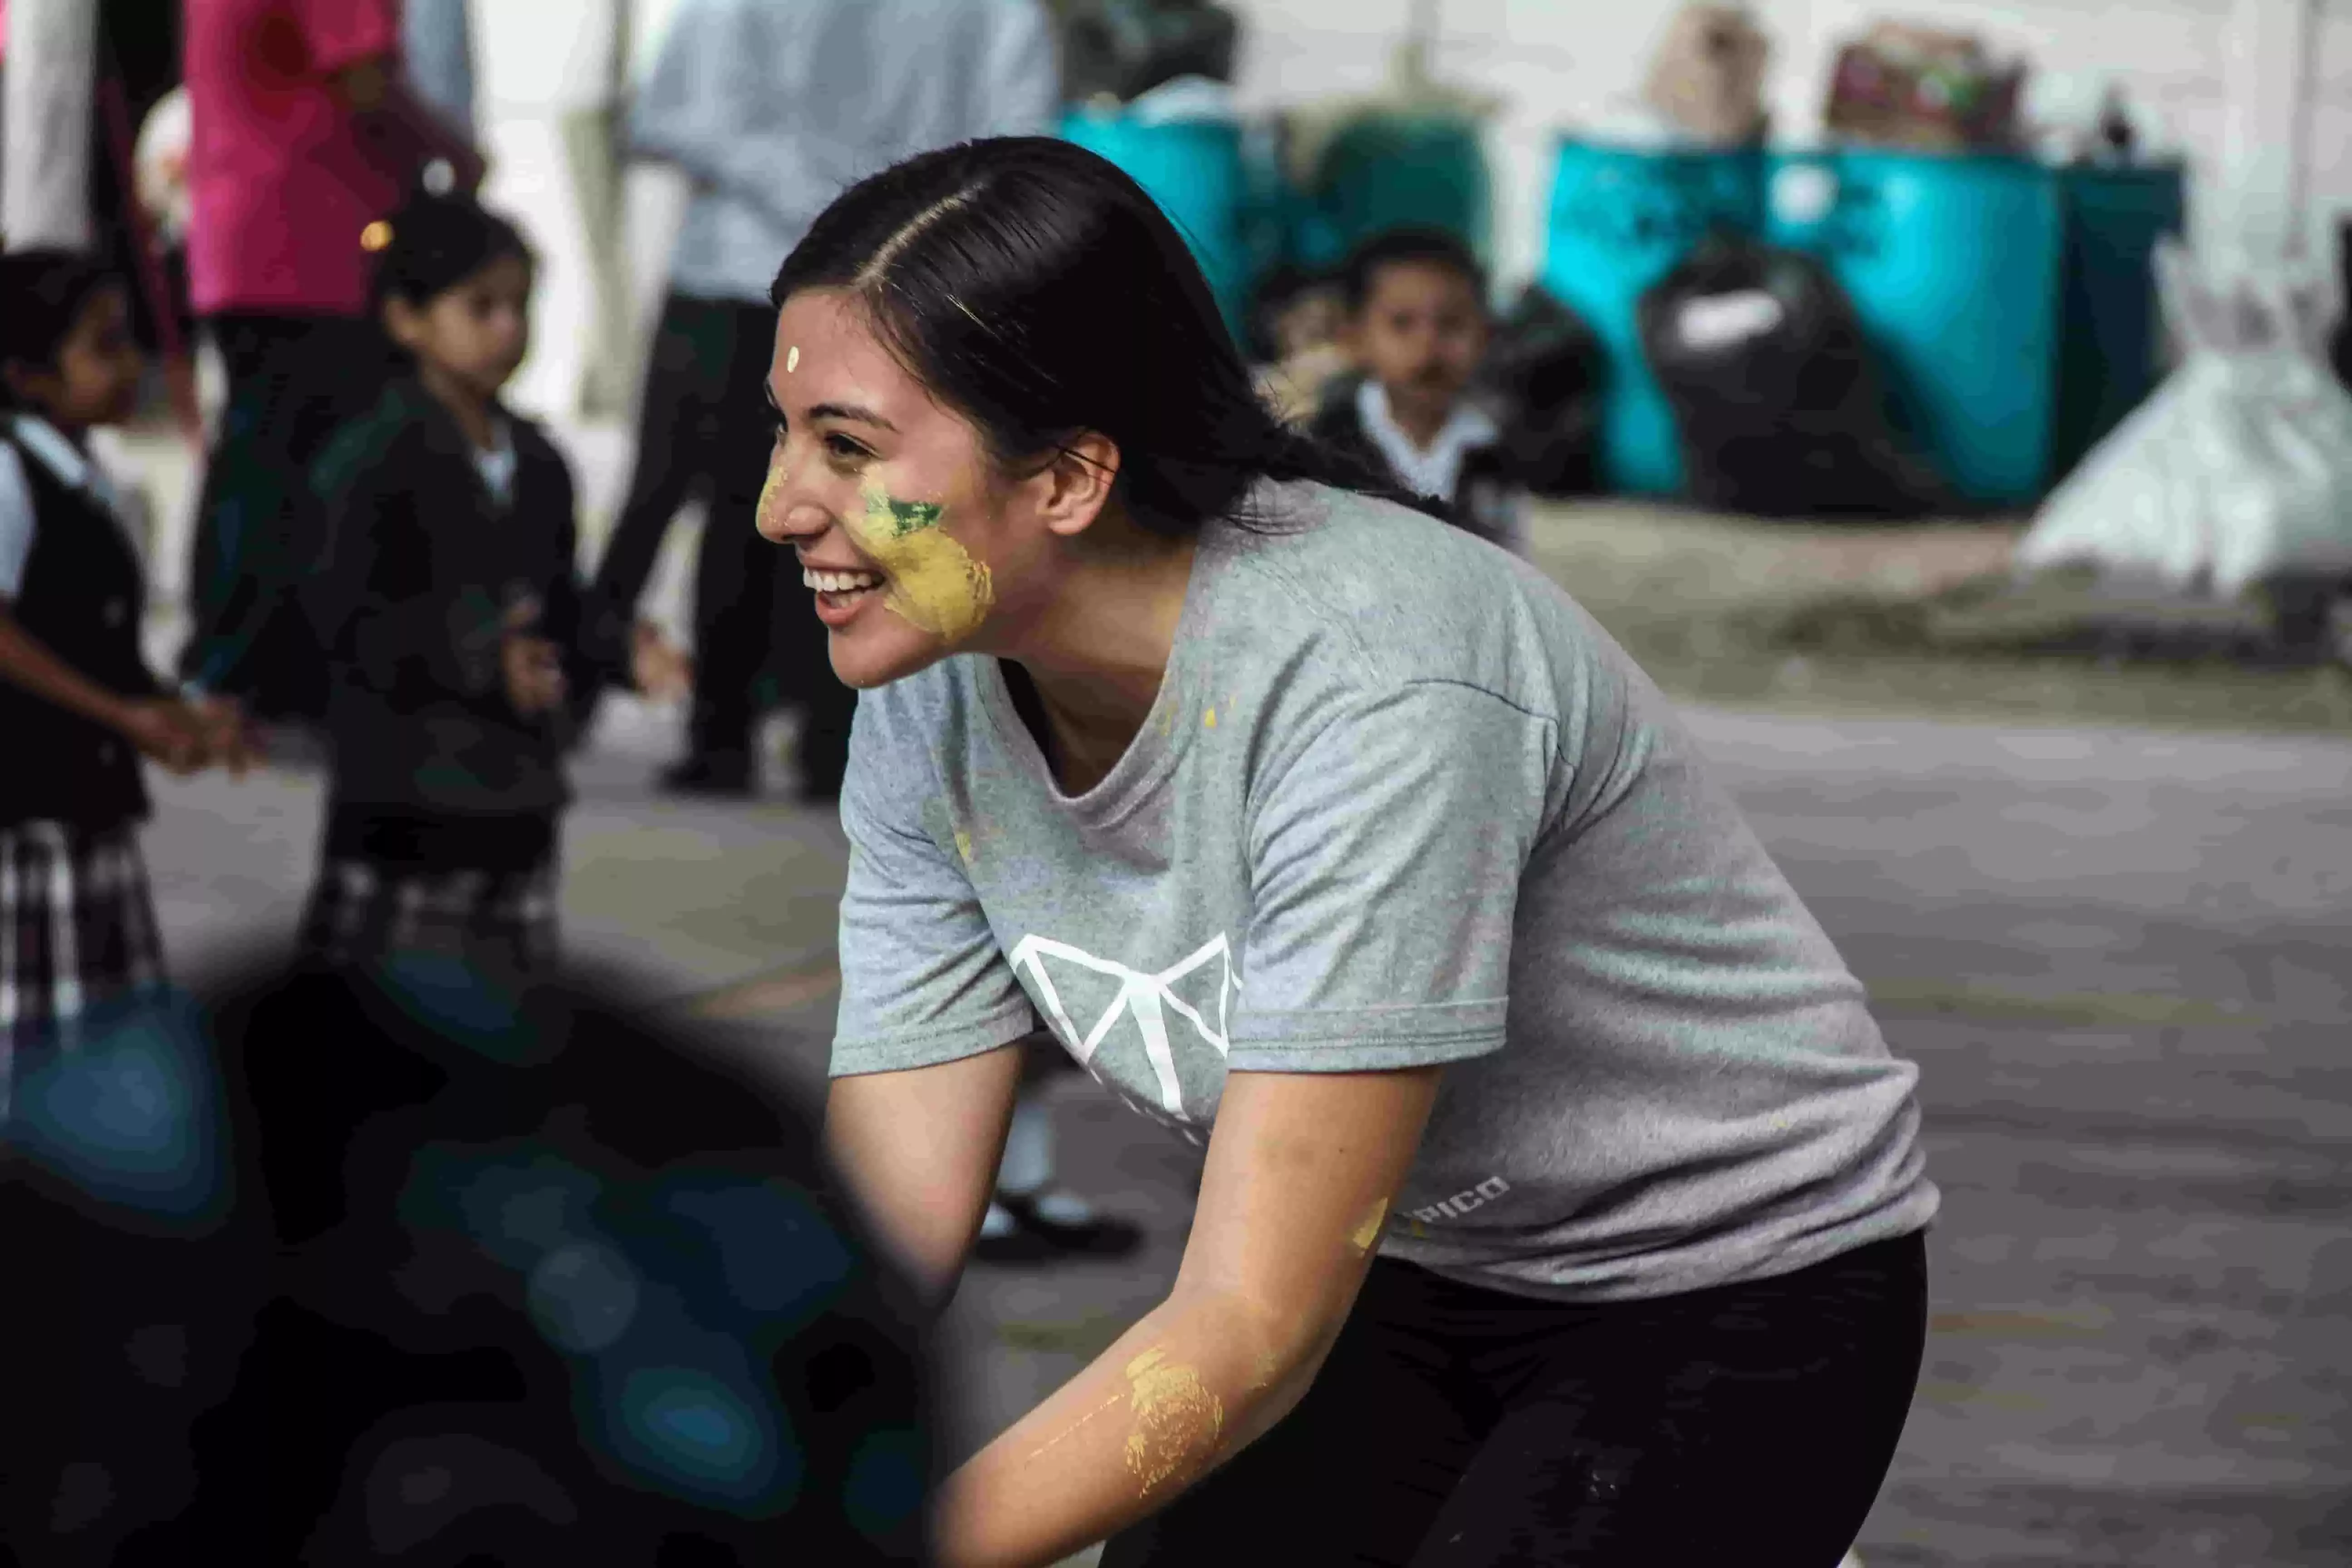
[934,1293,1329,1568]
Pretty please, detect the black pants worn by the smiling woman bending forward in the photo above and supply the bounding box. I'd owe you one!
[1103,1234,1926,1568]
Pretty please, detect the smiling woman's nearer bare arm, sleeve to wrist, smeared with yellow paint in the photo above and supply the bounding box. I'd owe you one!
[936,1053,1440,1568]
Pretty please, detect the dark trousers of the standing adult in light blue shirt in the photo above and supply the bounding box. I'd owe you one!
[583,294,856,785]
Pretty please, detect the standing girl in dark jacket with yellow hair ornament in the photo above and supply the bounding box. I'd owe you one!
[301,197,685,980]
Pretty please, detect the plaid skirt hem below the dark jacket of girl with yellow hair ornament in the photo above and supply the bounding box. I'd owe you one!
[299,853,558,978]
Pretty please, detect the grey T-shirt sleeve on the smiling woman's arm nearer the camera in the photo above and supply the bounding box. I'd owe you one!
[1228,682,1557,1072]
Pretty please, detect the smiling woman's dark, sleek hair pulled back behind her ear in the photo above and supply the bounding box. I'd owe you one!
[769,137,1402,534]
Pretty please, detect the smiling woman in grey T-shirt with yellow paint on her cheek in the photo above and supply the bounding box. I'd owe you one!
[760,139,1938,1568]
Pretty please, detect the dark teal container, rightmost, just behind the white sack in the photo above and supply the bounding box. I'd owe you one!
[2051,165,2187,482]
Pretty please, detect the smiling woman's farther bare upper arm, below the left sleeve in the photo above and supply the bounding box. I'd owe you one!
[826,1041,1023,1305]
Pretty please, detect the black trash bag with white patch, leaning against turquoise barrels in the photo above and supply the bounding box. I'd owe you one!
[1639,235,1959,522]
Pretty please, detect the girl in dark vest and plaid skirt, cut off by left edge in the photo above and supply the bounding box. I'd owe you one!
[0,249,242,1117]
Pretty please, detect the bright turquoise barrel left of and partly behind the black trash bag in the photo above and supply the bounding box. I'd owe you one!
[1543,139,1764,496]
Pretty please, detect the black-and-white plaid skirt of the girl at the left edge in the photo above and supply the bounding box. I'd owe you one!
[0,823,165,1117]
